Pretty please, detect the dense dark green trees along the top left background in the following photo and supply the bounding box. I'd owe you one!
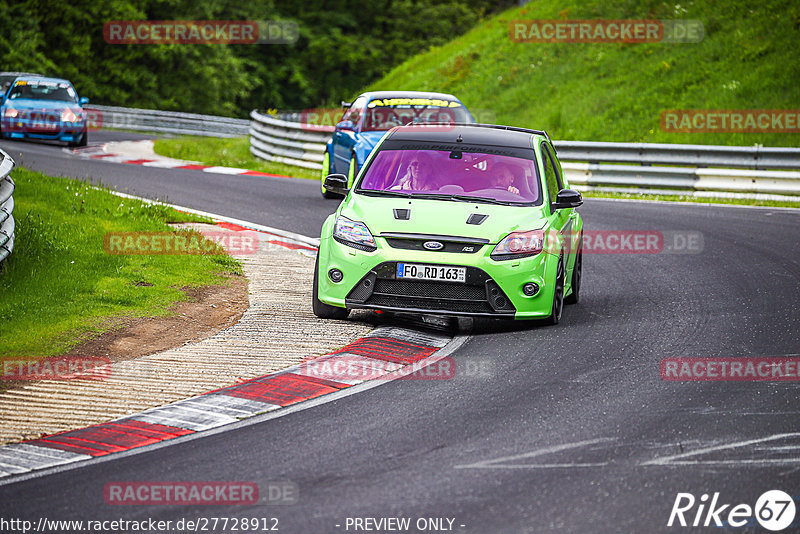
[0,0,514,116]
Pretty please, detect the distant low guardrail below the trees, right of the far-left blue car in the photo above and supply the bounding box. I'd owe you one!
[85,105,250,137]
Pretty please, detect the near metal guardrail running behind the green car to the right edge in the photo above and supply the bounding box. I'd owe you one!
[250,111,800,195]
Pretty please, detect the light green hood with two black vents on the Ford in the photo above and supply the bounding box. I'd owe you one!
[340,194,547,244]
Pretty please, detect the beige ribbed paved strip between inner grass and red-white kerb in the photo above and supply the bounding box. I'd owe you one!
[0,225,373,445]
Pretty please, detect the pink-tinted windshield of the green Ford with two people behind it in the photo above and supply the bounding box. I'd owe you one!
[359,150,541,203]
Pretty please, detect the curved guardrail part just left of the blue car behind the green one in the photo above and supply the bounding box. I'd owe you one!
[250,110,333,170]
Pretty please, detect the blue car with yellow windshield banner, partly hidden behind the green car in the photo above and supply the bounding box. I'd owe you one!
[321,91,475,198]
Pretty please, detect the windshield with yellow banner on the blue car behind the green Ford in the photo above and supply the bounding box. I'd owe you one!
[361,98,473,132]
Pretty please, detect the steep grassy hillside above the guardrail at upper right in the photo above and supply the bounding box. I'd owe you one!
[365,0,800,146]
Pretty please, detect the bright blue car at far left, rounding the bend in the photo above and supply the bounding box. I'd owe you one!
[0,76,89,146]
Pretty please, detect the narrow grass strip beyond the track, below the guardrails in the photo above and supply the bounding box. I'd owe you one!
[154,136,319,180]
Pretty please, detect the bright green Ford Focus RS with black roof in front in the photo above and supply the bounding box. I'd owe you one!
[312,124,583,324]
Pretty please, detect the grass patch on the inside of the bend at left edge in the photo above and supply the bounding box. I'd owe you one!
[0,169,241,358]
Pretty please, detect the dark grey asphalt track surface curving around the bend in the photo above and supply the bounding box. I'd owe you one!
[0,133,800,533]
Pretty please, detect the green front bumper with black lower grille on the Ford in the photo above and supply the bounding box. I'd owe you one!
[318,222,566,319]
